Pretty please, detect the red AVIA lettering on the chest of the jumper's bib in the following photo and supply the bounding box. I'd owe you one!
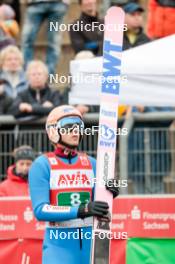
[58,171,90,186]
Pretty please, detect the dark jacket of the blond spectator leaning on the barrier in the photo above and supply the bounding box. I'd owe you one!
[8,86,62,117]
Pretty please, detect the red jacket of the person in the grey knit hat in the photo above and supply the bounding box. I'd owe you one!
[0,165,29,196]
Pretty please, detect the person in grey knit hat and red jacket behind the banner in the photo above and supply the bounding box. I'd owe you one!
[0,145,35,196]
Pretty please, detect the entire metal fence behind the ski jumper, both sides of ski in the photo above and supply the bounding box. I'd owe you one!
[0,112,175,194]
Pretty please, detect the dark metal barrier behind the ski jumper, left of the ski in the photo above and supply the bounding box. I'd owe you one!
[0,114,101,180]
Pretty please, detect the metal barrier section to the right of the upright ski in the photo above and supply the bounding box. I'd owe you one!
[119,112,175,194]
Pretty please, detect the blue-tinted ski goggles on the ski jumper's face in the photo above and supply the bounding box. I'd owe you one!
[57,116,84,133]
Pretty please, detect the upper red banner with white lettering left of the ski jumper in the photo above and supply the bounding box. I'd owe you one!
[0,197,45,240]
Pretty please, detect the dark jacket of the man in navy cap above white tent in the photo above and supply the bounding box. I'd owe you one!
[123,28,150,50]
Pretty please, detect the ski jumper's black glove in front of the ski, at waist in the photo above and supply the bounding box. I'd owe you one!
[77,201,109,218]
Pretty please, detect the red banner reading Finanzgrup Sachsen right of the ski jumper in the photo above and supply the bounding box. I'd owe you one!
[112,195,175,238]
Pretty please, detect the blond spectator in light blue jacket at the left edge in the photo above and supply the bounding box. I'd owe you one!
[0,45,27,98]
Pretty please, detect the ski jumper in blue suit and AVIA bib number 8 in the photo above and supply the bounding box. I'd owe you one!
[29,105,119,264]
